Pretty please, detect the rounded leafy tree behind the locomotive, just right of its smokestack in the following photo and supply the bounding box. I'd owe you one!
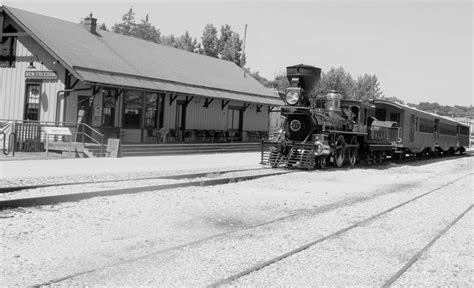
[311,67,355,99]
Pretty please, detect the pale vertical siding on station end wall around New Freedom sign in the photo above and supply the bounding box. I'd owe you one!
[0,37,65,121]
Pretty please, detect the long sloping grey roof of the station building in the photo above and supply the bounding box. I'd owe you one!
[1,6,283,105]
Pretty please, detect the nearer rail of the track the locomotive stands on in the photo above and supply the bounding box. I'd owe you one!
[0,171,292,210]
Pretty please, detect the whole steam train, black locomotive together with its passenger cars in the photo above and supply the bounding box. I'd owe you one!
[261,64,469,169]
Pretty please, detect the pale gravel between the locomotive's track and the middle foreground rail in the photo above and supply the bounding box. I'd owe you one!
[0,157,472,286]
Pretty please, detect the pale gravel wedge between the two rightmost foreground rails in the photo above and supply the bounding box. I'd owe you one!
[232,173,472,287]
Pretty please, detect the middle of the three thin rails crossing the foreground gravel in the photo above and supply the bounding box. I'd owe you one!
[207,173,474,288]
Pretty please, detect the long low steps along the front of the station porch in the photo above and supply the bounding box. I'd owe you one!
[85,142,261,157]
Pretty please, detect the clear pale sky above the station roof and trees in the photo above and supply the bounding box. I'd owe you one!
[0,0,474,106]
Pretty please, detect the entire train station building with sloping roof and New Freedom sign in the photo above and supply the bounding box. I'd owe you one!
[0,6,282,151]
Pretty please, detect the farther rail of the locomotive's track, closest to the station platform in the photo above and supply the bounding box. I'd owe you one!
[0,168,268,194]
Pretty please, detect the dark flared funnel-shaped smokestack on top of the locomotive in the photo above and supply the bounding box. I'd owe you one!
[286,64,321,98]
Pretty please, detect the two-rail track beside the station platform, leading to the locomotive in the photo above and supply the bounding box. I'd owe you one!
[0,168,295,210]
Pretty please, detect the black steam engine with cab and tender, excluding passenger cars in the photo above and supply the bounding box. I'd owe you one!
[261,64,398,169]
